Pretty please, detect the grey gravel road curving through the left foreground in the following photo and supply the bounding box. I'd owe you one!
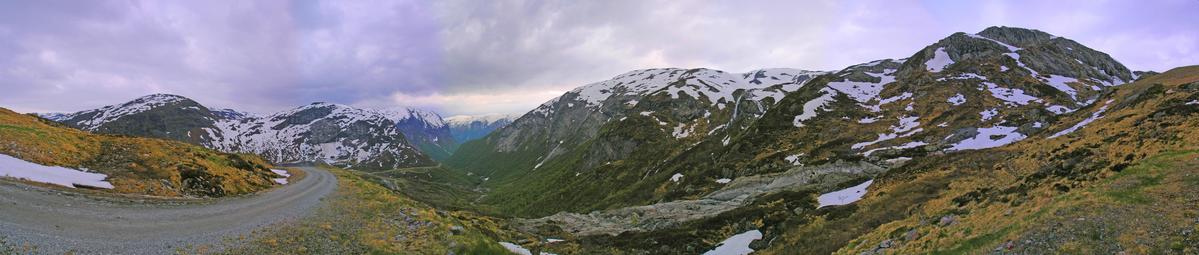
[0,168,337,254]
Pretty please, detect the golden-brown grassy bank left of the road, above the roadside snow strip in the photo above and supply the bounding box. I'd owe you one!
[0,109,272,196]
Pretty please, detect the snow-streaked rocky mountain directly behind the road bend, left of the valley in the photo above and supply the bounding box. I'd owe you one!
[207,103,433,169]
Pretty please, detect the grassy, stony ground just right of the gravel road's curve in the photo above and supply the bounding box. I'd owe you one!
[221,168,528,254]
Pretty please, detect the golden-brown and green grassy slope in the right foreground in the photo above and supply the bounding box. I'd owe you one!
[752,67,1199,254]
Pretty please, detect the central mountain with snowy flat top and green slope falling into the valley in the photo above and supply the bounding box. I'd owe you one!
[447,68,824,212]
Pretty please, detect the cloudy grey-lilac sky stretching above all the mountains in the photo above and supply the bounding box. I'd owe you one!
[0,0,1199,116]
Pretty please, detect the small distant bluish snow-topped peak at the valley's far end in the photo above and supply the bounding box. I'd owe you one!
[379,109,458,160]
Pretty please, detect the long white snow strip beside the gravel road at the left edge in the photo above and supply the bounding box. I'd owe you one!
[0,154,113,189]
